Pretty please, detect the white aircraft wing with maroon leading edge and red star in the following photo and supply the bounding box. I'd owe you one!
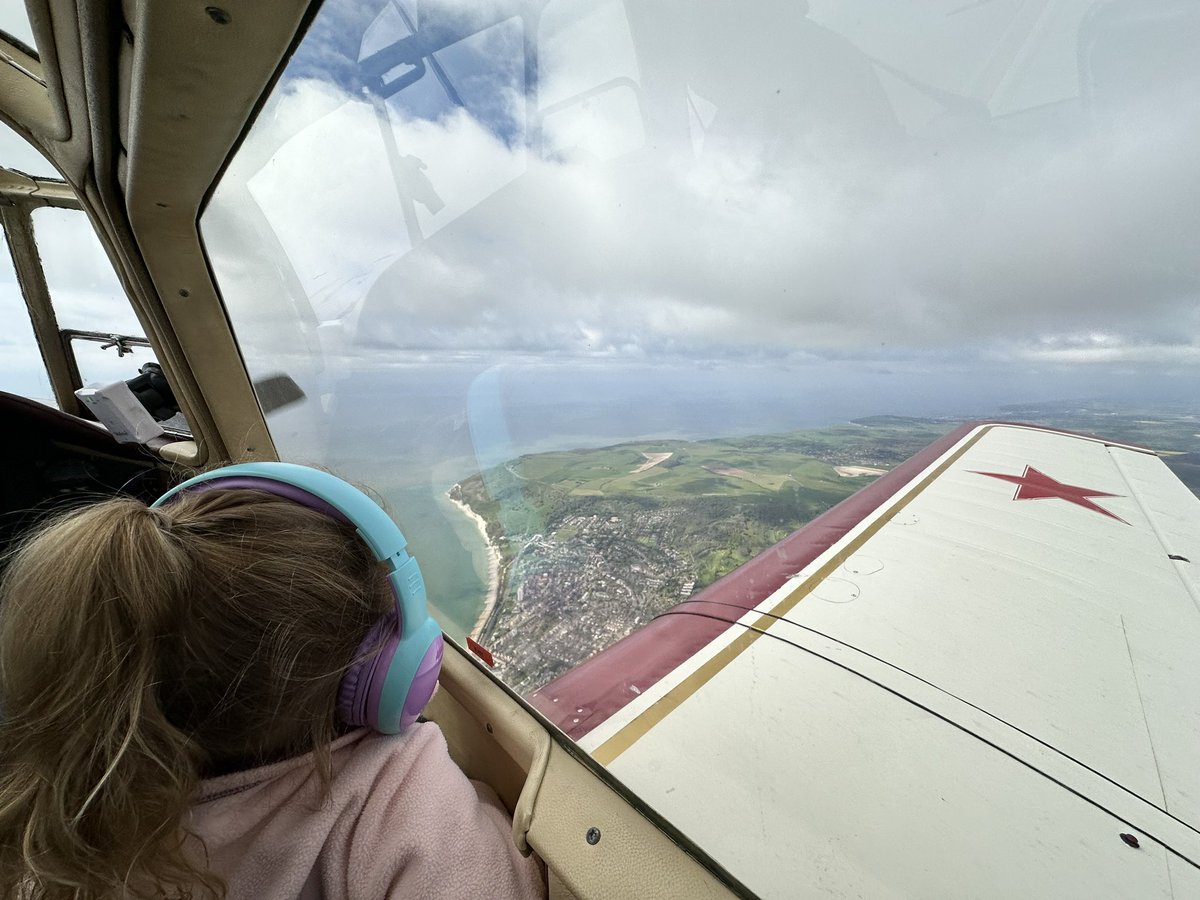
[533,424,1200,896]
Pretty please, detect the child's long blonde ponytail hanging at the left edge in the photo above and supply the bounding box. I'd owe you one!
[0,500,221,899]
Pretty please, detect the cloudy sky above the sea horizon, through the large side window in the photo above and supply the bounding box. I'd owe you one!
[2,0,1200,444]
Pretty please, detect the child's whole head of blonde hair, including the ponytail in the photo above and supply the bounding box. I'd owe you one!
[0,490,391,900]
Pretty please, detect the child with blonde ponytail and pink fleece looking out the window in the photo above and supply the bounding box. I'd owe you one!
[0,468,545,900]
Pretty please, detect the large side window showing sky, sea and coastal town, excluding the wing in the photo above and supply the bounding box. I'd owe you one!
[200,0,1200,888]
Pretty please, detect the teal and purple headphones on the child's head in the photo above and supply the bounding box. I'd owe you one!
[151,462,443,734]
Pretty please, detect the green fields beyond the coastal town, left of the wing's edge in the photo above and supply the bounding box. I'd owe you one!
[462,419,953,595]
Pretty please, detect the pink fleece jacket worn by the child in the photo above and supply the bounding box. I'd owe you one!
[192,724,546,900]
